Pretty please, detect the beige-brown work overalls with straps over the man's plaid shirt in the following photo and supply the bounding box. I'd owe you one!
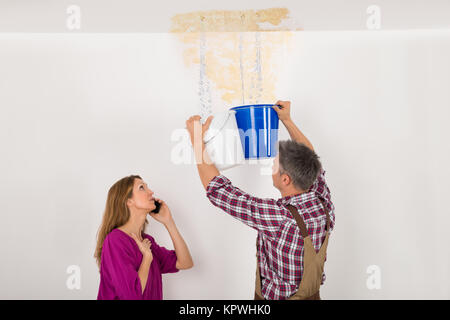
[255,201,330,300]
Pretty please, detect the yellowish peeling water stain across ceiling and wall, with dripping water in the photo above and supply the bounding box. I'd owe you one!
[170,8,301,113]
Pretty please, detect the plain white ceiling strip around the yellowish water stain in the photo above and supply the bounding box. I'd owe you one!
[0,0,450,32]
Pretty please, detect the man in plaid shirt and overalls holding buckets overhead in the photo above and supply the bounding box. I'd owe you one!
[186,101,335,300]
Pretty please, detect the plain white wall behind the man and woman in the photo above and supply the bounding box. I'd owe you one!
[0,31,450,299]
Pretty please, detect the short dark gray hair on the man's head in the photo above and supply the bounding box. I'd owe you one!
[278,140,322,191]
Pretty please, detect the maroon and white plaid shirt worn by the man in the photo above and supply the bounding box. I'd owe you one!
[206,169,335,300]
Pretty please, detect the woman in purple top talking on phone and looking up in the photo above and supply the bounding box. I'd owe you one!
[94,175,193,300]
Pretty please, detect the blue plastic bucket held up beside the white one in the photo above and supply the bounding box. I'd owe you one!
[230,104,279,159]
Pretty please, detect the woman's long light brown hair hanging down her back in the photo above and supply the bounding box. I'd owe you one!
[94,175,148,269]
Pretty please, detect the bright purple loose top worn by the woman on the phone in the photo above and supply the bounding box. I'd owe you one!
[97,229,178,300]
